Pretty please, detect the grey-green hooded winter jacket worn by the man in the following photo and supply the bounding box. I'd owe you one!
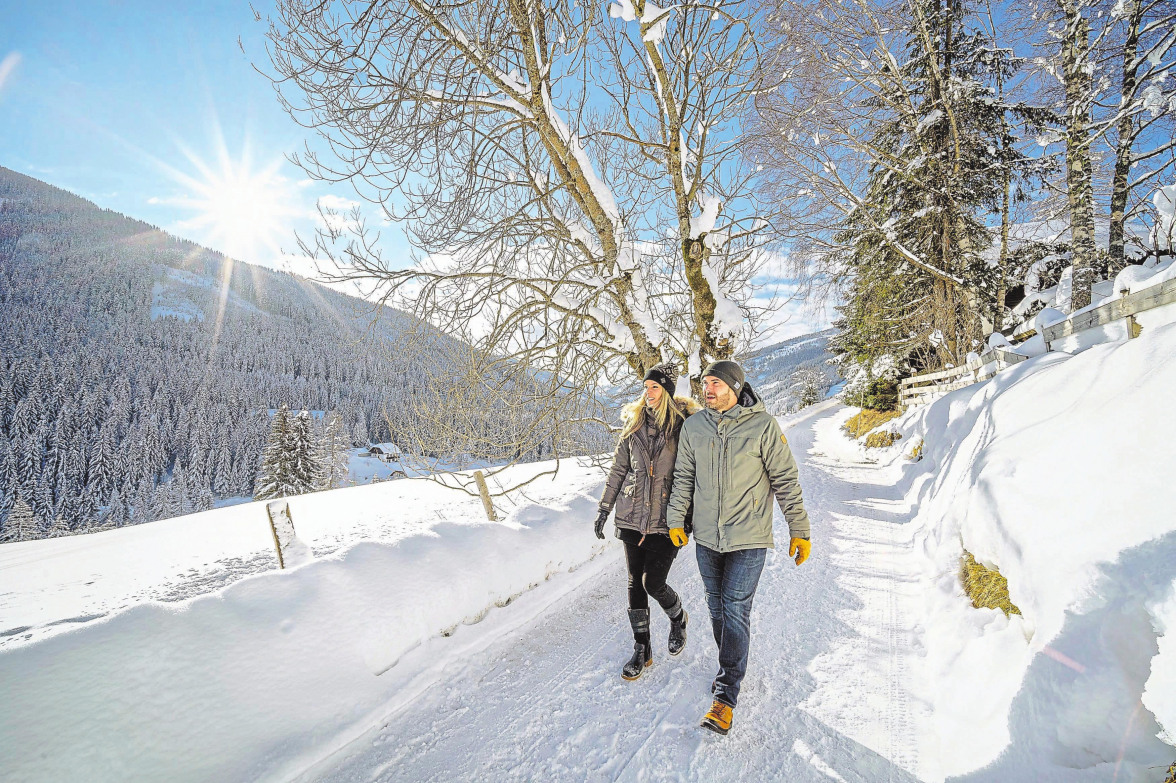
[667,386,809,553]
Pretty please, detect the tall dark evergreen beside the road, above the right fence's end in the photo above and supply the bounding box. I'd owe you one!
[833,0,1023,372]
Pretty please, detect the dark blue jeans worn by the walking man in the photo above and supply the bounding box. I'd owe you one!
[694,543,768,707]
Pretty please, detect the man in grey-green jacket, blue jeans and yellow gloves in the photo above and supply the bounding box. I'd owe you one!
[667,361,810,734]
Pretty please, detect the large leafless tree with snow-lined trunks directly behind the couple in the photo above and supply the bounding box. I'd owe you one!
[268,0,785,397]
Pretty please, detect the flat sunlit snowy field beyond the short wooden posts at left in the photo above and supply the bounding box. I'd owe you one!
[0,459,600,650]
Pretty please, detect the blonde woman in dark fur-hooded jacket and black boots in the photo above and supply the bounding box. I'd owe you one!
[596,364,700,680]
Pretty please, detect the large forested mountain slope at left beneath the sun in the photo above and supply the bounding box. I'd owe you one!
[0,169,491,533]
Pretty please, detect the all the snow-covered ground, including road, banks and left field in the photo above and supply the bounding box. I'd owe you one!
[0,326,1176,783]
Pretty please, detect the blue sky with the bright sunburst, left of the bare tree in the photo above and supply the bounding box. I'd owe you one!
[0,0,408,273]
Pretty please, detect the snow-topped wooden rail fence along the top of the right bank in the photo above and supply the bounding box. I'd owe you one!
[898,272,1176,407]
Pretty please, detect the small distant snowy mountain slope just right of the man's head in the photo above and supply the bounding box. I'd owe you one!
[743,329,838,414]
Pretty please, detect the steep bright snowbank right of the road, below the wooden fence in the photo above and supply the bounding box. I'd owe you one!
[898,317,1176,782]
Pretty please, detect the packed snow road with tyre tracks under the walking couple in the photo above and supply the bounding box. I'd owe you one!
[300,403,936,782]
